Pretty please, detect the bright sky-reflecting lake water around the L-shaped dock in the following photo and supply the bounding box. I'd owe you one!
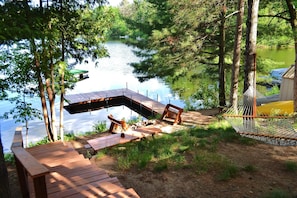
[0,42,184,152]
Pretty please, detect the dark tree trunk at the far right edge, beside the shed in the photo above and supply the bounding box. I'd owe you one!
[286,0,297,112]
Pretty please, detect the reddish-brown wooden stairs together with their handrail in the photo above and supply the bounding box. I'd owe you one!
[12,128,139,198]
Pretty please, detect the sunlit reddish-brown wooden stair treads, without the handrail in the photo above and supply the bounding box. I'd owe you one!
[27,142,139,197]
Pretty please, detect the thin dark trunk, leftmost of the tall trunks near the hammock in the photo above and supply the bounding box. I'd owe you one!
[219,0,226,107]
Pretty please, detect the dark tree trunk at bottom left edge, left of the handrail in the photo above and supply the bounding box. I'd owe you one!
[0,134,10,198]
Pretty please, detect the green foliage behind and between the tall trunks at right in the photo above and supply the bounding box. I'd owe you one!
[110,0,293,110]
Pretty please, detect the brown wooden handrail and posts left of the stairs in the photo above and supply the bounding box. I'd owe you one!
[11,127,49,198]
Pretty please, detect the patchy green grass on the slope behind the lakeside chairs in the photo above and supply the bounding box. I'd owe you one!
[101,121,254,181]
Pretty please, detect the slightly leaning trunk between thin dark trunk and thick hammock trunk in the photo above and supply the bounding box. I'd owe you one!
[230,0,245,110]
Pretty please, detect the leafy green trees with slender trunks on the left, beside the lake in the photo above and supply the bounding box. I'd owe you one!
[0,0,113,139]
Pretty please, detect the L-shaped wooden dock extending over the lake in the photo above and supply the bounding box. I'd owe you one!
[64,89,165,117]
